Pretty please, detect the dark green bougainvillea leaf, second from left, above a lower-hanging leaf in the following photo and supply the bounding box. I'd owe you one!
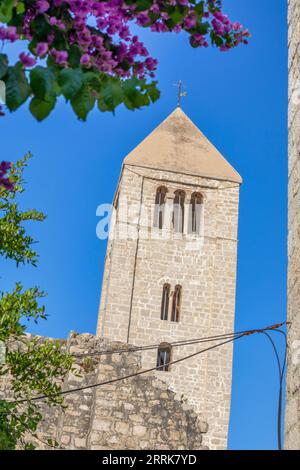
[30,65,59,100]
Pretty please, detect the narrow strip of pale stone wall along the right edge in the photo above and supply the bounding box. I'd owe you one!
[285,0,300,450]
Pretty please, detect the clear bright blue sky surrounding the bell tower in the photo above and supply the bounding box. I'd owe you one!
[0,0,287,449]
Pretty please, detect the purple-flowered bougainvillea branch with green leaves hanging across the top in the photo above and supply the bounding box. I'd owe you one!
[0,0,249,120]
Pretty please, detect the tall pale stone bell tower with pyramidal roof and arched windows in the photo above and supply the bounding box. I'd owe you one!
[97,107,242,449]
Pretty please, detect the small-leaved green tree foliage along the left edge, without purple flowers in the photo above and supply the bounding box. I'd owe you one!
[0,155,72,450]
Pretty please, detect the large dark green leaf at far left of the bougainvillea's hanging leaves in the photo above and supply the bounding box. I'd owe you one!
[5,62,30,111]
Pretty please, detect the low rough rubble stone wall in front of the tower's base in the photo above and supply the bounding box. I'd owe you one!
[0,333,208,450]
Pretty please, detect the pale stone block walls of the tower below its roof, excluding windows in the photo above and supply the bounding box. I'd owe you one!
[97,165,239,449]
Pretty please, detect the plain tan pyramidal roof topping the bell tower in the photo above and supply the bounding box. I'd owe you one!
[124,107,242,183]
